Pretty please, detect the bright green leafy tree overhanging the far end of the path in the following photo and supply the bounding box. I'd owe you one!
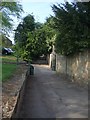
[27,17,55,59]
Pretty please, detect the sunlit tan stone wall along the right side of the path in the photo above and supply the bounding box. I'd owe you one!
[51,51,90,85]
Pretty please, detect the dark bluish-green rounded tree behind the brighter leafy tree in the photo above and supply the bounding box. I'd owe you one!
[15,15,35,47]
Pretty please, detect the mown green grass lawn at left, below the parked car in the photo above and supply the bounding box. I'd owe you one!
[0,55,22,82]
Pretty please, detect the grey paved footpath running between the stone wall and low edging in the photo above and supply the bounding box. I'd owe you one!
[19,65,88,118]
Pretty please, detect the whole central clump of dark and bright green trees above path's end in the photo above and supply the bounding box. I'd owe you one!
[15,15,54,59]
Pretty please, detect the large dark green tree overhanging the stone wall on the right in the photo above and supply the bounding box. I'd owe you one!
[52,2,90,55]
